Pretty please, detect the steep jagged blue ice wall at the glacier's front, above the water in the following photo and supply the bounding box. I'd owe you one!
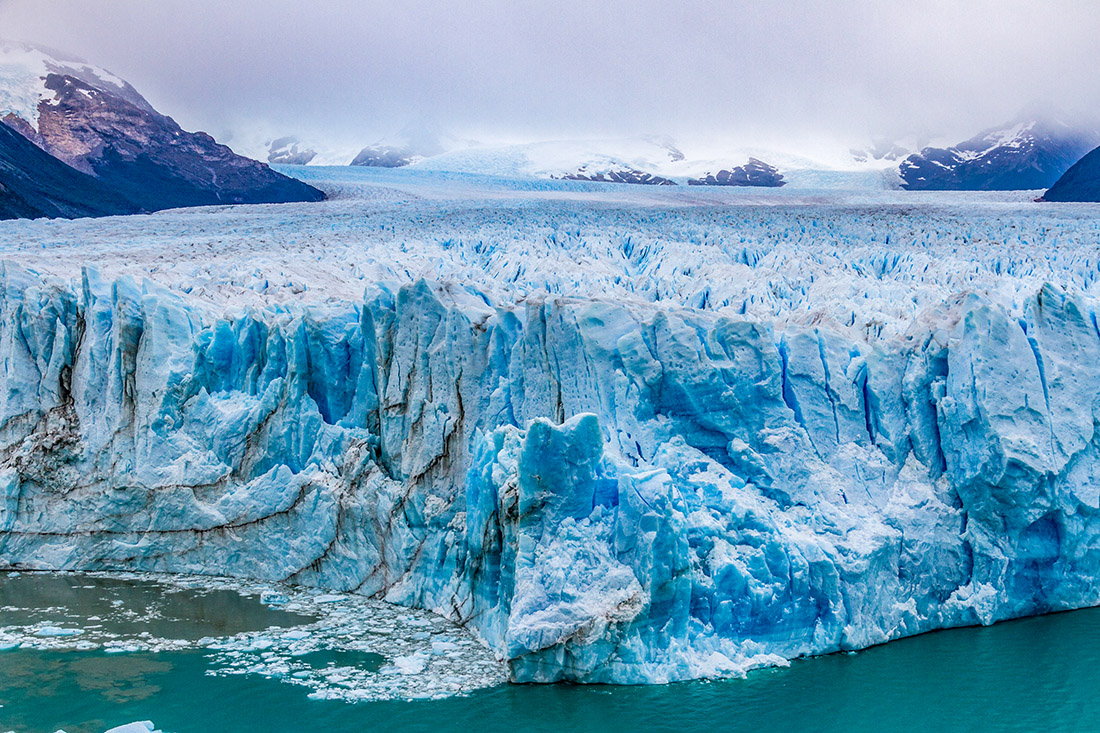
[0,259,1100,682]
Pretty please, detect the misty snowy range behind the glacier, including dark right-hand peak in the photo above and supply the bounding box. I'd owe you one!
[283,119,1100,190]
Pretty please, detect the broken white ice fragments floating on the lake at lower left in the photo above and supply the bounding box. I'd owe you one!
[0,572,506,699]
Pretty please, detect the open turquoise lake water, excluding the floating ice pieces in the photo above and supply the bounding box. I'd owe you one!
[0,573,1100,733]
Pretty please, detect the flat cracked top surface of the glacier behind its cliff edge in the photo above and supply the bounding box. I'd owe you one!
[0,167,1100,338]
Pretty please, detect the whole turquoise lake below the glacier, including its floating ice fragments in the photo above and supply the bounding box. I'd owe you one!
[0,573,1100,733]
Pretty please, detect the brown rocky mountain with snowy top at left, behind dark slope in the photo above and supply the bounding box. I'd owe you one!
[0,43,323,211]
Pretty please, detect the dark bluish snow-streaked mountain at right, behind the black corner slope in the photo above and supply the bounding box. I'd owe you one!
[899,120,1100,190]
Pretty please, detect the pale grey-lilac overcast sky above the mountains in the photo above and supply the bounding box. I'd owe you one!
[0,0,1100,152]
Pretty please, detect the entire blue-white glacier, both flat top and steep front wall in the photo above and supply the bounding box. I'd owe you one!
[0,168,1100,682]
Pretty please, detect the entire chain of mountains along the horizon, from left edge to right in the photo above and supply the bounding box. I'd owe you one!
[0,43,1100,205]
